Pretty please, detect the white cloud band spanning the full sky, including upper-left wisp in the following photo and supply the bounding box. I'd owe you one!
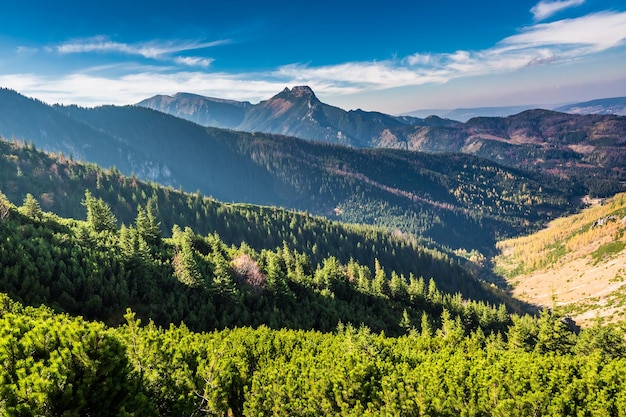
[0,12,626,106]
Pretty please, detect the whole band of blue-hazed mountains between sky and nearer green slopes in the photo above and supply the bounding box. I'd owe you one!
[0,87,626,253]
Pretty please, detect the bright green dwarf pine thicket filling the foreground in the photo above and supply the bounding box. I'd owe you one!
[0,294,626,417]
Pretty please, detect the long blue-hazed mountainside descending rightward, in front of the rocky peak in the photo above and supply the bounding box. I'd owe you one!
[0,89,574,251]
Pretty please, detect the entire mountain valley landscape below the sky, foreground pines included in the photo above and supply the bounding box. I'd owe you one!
[0,86,626,417]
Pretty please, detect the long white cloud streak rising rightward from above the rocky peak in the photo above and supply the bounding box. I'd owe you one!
[274,12,626,90]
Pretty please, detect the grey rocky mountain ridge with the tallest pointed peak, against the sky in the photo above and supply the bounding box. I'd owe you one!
[137,86,458,148]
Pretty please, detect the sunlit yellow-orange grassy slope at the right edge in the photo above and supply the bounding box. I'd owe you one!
[495,194,626,323]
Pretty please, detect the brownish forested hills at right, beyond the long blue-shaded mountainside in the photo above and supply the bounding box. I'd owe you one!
[381,110,626,197]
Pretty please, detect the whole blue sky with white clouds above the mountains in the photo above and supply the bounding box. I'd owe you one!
[0,0,626,114]
